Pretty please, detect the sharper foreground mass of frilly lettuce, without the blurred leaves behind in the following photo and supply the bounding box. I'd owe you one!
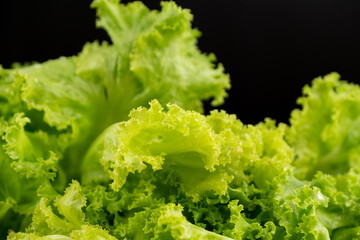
[5,78,360,239]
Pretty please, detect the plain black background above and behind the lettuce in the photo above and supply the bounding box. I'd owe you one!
[0,0,360,123]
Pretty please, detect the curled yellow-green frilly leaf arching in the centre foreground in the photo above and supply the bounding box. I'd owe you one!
[83,101,241,199]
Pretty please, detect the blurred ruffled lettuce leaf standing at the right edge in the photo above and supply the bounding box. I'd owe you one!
[286,73,360,179]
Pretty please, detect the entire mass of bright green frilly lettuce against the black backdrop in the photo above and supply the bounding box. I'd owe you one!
[0,0,360,240]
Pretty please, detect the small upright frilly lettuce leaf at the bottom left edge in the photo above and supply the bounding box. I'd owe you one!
[8,180,116,240]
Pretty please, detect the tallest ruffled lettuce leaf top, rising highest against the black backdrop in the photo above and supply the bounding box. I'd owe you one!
[92,0,230,111]
